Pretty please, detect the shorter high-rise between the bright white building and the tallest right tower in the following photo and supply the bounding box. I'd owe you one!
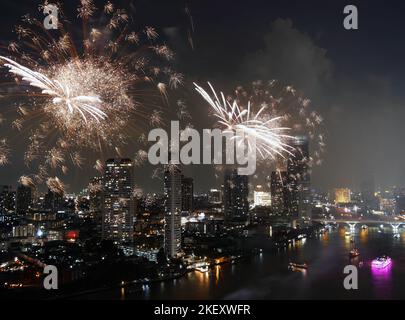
[270,171,288,214]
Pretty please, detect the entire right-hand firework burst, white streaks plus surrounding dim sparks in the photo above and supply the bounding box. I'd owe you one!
[195,80,326,191]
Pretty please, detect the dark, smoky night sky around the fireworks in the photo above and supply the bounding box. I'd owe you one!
[0,0,405,191]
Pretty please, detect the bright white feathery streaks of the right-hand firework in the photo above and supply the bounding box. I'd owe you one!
[194,83,293,159]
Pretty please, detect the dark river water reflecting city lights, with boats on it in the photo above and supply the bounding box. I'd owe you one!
[80,227,405,299]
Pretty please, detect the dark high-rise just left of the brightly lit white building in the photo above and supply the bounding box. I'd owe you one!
[223,169,249,220]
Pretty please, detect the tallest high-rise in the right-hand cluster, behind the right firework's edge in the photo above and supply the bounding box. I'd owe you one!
[287,136,311,219]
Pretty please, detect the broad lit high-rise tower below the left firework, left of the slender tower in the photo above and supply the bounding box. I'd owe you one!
[102,159,135,244]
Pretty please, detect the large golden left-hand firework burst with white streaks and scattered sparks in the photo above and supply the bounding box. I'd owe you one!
[0,0,183,189]
